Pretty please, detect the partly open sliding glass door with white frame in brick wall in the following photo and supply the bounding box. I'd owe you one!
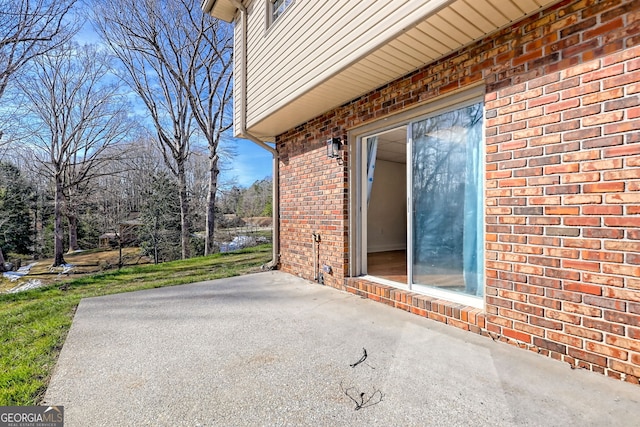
[352,94,484,307]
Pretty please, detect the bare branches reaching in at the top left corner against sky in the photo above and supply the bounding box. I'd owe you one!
[0,0,76,271]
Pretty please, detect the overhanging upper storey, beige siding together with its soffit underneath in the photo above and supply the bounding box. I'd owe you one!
[236,0,557,137]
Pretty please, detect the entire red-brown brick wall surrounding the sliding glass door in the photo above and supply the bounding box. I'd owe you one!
[277,0,640,382]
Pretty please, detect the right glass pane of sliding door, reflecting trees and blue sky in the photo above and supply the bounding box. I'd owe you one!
[408,103,484,296]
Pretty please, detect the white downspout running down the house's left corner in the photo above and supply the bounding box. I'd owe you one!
[230,0,280,269]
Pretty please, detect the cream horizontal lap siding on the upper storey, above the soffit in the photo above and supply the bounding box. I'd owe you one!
[241,0,444,126]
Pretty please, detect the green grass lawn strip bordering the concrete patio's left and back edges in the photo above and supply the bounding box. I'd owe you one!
[0,245,271,406]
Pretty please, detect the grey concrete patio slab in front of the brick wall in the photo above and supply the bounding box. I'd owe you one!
[44,272,640,427]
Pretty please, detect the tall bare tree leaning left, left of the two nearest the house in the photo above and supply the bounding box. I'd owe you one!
[94,0,193,259]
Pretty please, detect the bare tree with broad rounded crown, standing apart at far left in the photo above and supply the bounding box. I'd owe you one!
[20,44,130,266]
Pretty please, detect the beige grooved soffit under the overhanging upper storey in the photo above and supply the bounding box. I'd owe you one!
[248,0,559,138]
